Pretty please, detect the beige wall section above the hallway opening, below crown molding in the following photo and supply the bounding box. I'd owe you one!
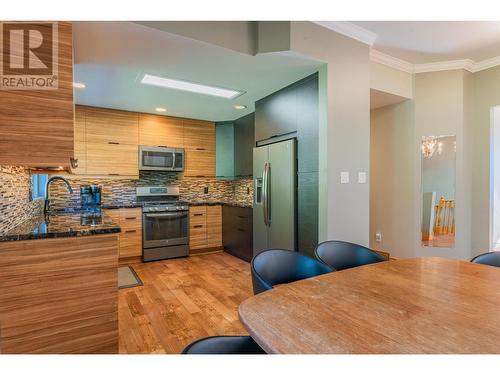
[370,61,413,99]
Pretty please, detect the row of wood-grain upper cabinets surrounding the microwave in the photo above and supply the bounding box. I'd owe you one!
[72,106,215,178]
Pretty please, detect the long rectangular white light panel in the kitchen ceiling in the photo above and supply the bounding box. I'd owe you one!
[141,74,245,99]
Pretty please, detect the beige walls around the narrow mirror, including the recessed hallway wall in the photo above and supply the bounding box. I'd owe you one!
[370,70,475,259]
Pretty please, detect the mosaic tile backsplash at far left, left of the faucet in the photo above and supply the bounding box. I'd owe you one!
[0,165,44,234]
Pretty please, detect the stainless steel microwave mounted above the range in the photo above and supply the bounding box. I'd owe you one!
[139,146,184,172]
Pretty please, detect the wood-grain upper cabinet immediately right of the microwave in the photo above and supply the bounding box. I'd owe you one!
[183,119,215,177]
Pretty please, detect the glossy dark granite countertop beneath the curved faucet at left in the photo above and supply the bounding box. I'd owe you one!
[0,211,121,242]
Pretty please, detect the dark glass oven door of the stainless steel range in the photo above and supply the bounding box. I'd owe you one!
[142,211,188,249]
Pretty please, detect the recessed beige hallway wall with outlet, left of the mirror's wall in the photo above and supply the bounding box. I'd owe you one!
[370,100,416,258]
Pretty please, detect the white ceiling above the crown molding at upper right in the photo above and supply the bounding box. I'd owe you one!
[351,21,500,64]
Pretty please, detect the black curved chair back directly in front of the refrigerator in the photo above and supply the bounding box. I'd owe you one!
[251,249,335,294]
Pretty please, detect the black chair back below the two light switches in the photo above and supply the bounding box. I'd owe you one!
[314,241,387,271]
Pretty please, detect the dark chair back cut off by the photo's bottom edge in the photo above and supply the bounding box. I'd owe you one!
[182,336,266,354]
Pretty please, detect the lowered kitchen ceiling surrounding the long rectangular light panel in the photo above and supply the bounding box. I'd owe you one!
[73,22,320,121]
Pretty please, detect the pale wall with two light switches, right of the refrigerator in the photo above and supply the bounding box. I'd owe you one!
[290,22,370,245]
